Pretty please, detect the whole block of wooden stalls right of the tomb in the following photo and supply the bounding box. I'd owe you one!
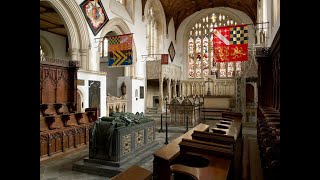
[153,112,242,180]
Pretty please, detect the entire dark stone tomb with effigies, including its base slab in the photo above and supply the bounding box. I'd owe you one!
[72,112,158,177]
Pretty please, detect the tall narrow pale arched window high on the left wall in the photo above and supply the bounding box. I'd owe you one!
[147,7,158,57]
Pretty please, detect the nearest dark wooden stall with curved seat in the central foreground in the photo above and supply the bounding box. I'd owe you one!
[170,139,233,180]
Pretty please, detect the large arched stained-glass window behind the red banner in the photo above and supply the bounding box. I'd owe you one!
[188,13,243,79]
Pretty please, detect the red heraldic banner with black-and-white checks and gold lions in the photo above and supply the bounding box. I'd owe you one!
[213,25,248,62]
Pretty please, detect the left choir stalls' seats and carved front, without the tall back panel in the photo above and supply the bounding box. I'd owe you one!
[40,103,96,162]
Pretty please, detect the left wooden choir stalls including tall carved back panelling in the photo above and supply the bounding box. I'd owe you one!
[40,58,97,162]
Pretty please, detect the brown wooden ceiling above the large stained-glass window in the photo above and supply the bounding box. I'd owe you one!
[142,0,257,33]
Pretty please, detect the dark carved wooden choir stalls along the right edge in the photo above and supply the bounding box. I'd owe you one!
[256,28,281,180]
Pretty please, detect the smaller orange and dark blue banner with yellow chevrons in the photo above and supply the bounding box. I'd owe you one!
[107,34,133,67]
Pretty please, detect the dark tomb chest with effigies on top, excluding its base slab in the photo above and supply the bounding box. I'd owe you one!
[86,112,155,164]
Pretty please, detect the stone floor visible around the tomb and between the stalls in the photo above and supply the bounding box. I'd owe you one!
[40,121,262,180]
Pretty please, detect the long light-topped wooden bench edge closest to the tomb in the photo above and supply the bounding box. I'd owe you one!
[153,123,209,180]
